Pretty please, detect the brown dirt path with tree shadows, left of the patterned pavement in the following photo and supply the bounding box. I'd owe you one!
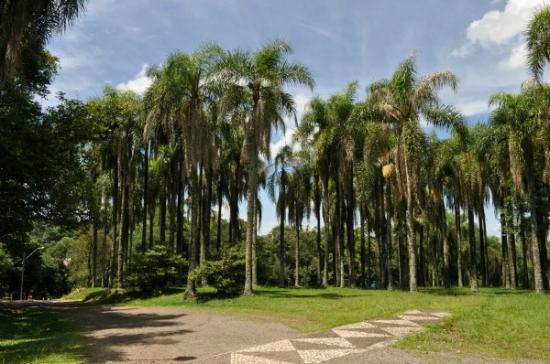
[37,302,299,363]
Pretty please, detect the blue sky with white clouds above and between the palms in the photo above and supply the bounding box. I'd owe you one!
[43,0,548,236]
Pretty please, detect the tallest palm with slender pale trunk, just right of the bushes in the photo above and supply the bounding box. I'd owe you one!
[218,40,314,296]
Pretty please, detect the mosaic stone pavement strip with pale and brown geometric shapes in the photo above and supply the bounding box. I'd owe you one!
[219,310,448,364]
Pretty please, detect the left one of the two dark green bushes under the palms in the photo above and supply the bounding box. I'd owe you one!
[126,245,186,293]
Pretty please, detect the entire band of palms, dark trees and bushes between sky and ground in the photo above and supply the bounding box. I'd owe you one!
[0,1,550,298]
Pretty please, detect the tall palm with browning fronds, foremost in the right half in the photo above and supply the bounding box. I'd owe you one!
[373,57,463,291]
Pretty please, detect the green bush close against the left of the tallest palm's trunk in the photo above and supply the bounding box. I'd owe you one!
[191,249,245,296]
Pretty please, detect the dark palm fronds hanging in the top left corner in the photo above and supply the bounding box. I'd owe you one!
[0,0,86,87]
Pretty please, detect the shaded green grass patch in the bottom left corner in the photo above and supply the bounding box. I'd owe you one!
[0,303,85,364]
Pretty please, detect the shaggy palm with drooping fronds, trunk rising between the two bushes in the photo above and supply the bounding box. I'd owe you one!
[145,45,226,298]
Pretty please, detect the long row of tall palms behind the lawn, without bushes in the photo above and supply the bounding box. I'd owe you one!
[83,9,550,298]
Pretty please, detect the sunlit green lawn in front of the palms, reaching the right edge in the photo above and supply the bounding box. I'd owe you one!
[64,288,550,360]
